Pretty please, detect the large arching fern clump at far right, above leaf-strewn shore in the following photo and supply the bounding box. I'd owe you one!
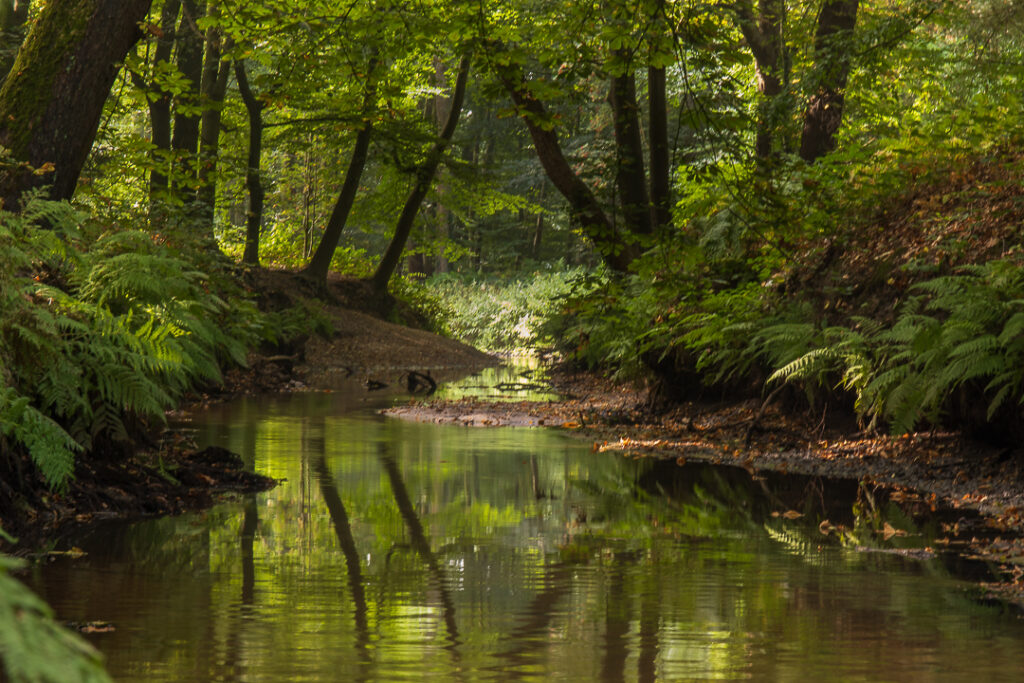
[769,261,1024,432]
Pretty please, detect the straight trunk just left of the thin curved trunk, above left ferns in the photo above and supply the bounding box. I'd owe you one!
[196,2,231,232]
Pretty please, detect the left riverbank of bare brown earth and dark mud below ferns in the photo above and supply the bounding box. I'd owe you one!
[0,269,498,554]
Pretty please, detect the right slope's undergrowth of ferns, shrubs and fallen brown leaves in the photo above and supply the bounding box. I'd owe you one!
[546,141,1024,438]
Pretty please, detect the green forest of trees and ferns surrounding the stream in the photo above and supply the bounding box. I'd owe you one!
[0,0,1024,680]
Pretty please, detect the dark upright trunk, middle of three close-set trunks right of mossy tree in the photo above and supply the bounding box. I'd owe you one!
[171,0,206,192]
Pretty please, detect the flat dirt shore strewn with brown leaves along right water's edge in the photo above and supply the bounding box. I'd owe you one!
[386,371,1024,607]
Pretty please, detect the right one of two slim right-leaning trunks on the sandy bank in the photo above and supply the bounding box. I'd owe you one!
[370,55,470,292]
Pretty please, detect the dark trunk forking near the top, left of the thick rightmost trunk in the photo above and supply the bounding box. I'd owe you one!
[734,0,785,160]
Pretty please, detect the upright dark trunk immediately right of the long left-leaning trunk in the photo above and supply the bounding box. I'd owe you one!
[608,59,651,240]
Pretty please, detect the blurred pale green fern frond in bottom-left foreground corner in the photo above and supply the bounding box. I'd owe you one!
[0,556,111,683]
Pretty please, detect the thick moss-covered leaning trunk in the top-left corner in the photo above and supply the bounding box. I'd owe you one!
[0,0,152,209]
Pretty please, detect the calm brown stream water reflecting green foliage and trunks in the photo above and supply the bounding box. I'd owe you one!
[19,376,1024,683]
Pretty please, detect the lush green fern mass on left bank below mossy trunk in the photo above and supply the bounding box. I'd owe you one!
[0,194,265,487]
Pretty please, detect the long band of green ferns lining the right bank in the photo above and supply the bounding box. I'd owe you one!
[561,253,1024,432]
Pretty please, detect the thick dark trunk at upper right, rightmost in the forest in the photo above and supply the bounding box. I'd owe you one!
[800,0,859,163]
